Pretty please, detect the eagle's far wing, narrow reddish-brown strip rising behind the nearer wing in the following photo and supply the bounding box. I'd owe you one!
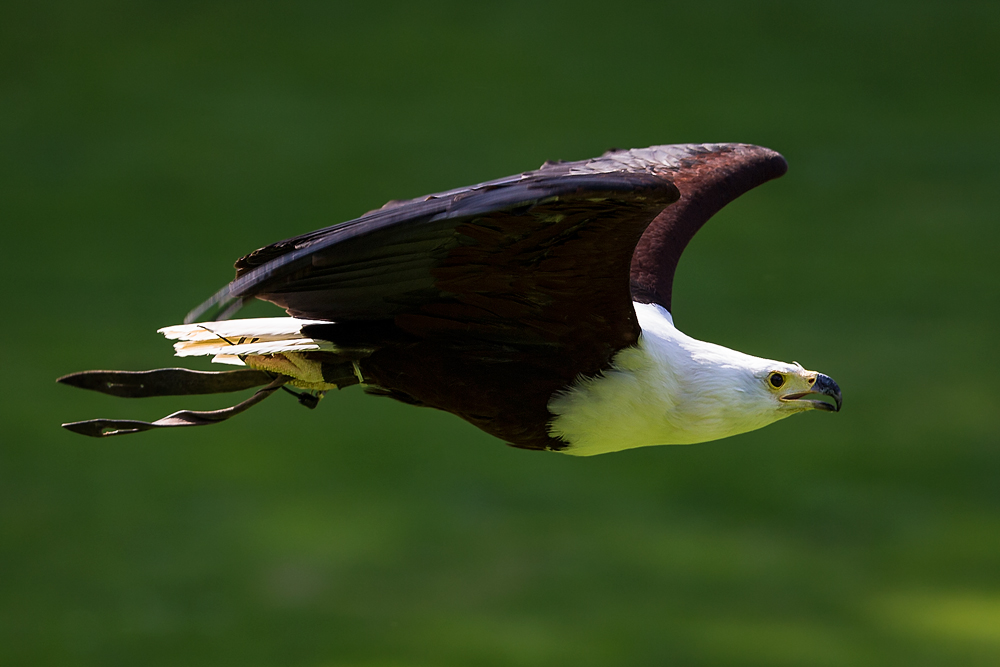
[616,144,788,310]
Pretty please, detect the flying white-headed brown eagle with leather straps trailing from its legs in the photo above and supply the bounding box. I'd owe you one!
[58,143,842,456]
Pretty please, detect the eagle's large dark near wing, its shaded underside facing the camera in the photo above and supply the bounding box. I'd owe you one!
[186,170,679,356]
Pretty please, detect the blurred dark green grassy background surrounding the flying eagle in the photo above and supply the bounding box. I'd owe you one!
[0,1,1000,667]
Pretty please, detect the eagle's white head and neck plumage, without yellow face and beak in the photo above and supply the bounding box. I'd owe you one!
[549,303,787,456]
